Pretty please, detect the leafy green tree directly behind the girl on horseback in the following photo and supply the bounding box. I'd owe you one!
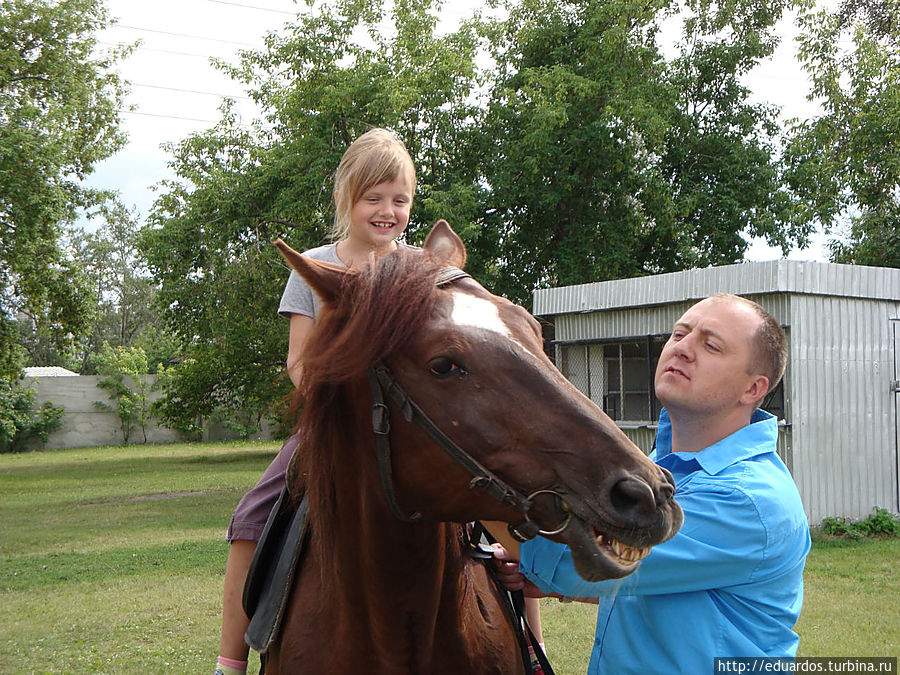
[141,0,486,428]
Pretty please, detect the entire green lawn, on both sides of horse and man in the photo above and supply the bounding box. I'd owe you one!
[0,443,900,675]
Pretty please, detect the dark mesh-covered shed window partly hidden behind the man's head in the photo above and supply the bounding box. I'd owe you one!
[556,335,785,423]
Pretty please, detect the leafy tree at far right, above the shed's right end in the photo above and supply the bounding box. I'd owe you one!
[786,0,900,267]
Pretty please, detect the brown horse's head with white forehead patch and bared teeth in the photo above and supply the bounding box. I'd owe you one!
[279,221,682,580]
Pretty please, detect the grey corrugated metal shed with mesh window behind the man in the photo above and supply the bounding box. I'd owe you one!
[534,260,900,524]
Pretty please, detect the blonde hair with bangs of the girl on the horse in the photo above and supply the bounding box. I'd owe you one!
[331,129,416,241]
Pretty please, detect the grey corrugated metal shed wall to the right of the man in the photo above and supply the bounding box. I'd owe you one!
[790,295,900,522]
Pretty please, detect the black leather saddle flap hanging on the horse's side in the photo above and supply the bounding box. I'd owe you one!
[243,488,309,654]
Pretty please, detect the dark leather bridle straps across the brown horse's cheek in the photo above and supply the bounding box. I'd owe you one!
[368,363,540,538]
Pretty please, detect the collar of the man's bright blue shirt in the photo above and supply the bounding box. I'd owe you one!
[656,408,778,475]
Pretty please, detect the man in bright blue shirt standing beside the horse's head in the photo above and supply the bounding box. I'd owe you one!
[490,294,810,674]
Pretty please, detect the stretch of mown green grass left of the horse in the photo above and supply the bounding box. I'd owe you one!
[0,443,278,674]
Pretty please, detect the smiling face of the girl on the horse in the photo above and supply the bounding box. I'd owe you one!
[349,176,413,249]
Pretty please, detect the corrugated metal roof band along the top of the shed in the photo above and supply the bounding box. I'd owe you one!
[534,260,900,316]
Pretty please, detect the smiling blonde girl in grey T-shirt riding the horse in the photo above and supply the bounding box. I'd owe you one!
[215,129,540,675]
